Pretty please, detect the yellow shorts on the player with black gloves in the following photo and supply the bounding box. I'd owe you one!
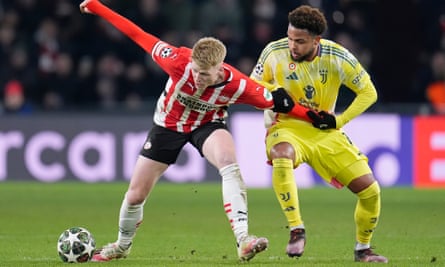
[266,121,372,185]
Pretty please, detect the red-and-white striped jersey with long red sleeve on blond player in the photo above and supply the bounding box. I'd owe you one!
[87,1,274,133]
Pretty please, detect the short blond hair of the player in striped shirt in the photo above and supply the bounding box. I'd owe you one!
[192,37,227,68]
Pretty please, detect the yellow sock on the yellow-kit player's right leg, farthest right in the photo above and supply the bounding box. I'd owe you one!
[354,182,380,244]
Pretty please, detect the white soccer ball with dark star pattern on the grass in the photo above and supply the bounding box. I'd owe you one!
[57,227,96,262]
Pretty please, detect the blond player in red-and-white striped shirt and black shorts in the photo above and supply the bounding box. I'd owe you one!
[80,0,311,261]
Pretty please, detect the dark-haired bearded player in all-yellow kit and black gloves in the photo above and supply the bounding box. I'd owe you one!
[251,5,388,263]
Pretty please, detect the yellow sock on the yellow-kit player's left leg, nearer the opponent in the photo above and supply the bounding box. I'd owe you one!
[272,158,303,229]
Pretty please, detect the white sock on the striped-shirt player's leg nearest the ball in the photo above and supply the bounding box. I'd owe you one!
[117,196,144,249]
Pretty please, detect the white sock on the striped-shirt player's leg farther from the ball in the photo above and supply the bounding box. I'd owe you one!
[219,163,248,242]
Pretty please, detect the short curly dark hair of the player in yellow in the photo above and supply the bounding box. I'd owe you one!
[288,5,328,35]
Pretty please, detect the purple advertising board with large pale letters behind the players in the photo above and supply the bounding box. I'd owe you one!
[0,111,445,188]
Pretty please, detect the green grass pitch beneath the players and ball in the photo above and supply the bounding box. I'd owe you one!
[0,182,445,266]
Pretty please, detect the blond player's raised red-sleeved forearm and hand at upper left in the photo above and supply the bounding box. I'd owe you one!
[79,0,159,54]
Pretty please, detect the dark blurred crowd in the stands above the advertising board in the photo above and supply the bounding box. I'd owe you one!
[0,0,445,113]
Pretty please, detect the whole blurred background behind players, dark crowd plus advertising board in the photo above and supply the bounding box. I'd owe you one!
[0,0,445,187]
